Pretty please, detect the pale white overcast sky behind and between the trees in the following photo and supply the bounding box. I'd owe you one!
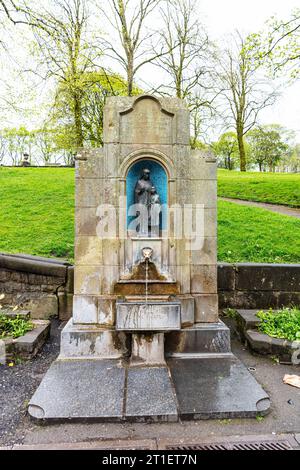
[0,0,300,142]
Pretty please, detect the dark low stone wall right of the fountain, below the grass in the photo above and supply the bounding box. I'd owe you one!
[218,263,300,309]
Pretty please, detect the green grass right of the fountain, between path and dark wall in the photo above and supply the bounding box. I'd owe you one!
[218,201,300,263]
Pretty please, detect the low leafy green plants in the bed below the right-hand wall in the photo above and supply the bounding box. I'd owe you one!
[257,307,300,342]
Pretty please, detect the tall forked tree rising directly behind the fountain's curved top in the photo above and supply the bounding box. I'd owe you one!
[101,0,165,96]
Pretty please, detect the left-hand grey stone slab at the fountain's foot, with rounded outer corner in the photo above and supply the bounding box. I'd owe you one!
[28,360,125,422]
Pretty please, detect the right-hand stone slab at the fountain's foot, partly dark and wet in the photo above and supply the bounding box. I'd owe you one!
[168,355,270,419]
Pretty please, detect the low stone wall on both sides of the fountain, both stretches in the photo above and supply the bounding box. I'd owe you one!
[0,253,300,320]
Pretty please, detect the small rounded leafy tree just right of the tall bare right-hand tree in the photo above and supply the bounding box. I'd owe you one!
[247,125,289,171]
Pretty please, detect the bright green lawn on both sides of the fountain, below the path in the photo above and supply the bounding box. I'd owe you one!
[0,167,300,263]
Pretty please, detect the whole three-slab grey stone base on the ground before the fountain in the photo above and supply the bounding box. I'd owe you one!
[28,353,270,423]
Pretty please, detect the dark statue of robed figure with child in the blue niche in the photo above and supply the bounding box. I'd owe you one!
[134,168,161,236]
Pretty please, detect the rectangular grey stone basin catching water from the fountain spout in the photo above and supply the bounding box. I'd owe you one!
[116,301,181,331]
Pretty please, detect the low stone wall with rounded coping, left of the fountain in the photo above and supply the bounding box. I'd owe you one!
[0,253,73,320]
